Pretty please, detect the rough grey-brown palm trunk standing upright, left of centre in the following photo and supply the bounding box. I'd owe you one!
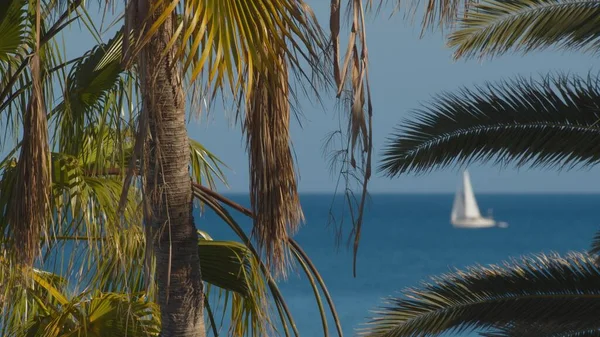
[138,0,206,337]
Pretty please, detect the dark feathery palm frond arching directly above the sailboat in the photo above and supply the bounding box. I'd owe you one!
[380,75,600,176]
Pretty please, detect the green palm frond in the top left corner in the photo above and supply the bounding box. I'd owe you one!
[0,0,82,147]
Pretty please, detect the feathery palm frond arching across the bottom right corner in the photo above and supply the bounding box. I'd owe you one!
[365,253,600,337]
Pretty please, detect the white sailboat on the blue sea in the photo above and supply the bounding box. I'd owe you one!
[450,170,496,228]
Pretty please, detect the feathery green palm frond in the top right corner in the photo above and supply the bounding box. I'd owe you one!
[448,0,600,58]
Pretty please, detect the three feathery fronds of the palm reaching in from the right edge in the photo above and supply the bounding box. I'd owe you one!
[365,0,600,336]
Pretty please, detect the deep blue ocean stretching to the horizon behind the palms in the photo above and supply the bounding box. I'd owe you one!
[196,194,600,337]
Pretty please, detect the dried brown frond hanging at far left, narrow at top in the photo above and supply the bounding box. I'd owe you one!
[7,0,51,264]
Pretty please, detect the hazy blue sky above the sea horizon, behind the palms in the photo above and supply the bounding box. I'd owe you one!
[29,0,600,193]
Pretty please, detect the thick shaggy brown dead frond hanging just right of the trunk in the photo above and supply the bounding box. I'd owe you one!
[244,50,304,276]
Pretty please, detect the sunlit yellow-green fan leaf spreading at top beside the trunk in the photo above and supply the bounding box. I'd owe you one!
[126,0,326,102]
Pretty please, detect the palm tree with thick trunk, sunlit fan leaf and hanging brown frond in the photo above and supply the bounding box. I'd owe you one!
[114,0,332,336]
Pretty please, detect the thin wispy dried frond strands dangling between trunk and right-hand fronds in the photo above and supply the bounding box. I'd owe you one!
[330,0,373,276]
